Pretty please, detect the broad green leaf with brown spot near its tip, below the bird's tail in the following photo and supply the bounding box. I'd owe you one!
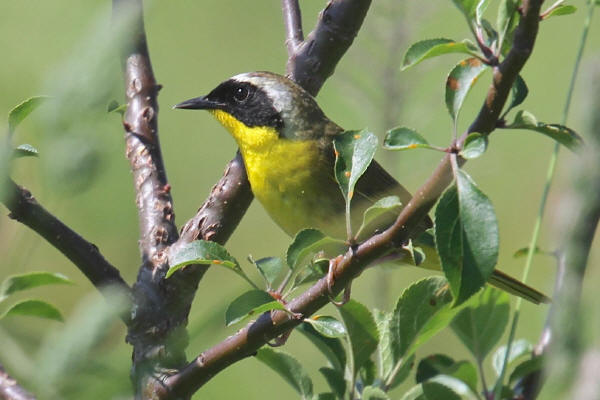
[385,276,460,381]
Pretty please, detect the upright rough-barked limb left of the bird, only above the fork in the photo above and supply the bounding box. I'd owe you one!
[113,0,178,269]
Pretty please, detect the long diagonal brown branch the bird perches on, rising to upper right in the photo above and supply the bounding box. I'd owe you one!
[162,0,543,397]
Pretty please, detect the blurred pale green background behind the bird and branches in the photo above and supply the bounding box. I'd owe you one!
[0,0,600,399]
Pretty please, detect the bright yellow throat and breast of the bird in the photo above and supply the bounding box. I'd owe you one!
[212,110,344,236]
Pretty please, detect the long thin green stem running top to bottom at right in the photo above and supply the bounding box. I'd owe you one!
[494,0,595,399]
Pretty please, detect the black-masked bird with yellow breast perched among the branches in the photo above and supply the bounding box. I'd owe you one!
[174,71,550,304]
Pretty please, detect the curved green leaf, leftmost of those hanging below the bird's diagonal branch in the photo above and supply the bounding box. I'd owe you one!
[255,347,313,399]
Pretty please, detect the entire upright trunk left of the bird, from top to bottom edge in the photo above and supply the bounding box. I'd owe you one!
[112,0,192,398]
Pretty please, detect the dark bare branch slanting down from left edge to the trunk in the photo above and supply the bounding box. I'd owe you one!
[2,180,131,293]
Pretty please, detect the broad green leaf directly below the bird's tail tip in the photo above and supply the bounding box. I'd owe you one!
[450,287,510,362]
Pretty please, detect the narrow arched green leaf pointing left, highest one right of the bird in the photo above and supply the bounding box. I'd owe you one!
[401,38,478,70]
